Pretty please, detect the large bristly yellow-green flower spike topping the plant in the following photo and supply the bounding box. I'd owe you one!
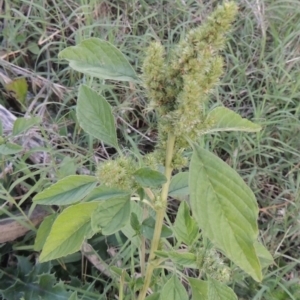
[142,2,237,168]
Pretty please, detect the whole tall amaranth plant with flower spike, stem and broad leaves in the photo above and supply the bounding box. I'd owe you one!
[33,2,272,300]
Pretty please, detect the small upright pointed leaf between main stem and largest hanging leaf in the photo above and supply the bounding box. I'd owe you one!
[173,201,199,246]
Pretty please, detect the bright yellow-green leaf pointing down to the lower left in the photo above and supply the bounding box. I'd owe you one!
[40,202,99,262]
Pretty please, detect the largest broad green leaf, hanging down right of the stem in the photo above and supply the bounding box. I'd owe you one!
[189,146,262,281]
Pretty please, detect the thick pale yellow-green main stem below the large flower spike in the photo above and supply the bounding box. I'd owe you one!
[138,133,175,300]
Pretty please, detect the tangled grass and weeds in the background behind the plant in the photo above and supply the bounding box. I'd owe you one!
[0,0,300,300]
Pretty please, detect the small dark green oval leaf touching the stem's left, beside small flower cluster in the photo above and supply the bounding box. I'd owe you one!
[133,168,167,187]
